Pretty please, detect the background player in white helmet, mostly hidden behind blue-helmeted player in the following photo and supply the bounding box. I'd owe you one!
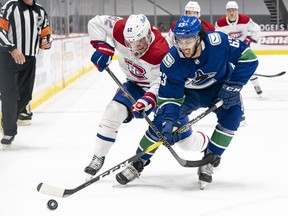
[168,1,215,46]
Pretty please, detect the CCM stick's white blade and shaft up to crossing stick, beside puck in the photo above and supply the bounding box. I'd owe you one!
[37,142,162,198]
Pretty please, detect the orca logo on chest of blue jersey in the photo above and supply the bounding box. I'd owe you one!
[185,70,216,89]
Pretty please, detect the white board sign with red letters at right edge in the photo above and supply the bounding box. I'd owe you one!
[251,31,288,50]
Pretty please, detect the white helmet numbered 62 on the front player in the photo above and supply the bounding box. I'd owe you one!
[124,14,151,42]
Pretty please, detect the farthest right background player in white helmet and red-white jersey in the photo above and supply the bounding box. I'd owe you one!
[215,1,262,96]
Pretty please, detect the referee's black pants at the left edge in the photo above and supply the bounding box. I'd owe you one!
[0,52,36,136]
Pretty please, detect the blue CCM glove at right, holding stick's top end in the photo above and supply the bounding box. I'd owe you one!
[218,81,243,109]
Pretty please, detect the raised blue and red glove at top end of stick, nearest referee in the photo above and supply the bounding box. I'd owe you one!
[91,41,115,72]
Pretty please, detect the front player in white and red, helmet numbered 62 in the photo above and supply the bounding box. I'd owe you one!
[84,14,169,176]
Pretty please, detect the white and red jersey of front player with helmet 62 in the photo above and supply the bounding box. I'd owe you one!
[88,15,169,95]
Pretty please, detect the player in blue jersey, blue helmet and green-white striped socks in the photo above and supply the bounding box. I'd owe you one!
[116,16,258,189]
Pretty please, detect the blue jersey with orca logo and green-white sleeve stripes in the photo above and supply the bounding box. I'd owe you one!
[159,31,258,106]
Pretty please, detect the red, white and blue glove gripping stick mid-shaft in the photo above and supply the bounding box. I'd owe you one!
[131,92,156,118]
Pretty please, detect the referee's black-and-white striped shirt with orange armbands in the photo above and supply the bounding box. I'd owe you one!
[0,0,51,56]
